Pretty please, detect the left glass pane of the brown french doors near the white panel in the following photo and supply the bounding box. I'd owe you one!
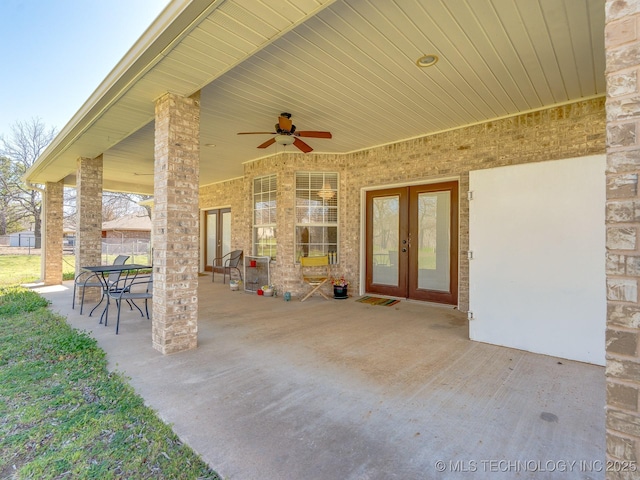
[371,195,400,287]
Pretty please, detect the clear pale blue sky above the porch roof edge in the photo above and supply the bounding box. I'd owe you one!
[0,0,169,137]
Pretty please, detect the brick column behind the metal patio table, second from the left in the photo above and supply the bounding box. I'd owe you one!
[76,155,102,301]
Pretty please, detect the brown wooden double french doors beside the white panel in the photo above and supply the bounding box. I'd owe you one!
[365,182,458,305]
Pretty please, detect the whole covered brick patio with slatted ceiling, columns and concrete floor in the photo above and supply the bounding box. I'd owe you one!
[24,0,640,472]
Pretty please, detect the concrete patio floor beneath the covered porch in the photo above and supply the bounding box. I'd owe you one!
[38,276,605,480]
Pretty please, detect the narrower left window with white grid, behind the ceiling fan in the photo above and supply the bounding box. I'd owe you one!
[253,175,277,260]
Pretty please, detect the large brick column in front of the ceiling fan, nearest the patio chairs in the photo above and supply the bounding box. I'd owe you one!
[152,93,200,354]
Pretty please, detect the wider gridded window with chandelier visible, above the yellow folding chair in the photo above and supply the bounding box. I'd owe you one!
[295,172,338,263]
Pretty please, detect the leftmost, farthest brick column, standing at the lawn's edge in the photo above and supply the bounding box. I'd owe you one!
[42,182,64,285]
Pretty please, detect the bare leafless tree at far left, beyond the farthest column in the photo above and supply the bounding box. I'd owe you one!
[0,118,56,247]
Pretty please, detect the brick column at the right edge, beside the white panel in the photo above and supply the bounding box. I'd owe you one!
[605,0,640,472]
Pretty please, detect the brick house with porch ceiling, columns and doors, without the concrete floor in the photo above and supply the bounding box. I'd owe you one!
[20,0,640,459]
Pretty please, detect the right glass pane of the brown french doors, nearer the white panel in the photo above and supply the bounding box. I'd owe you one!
[412,191,451,292]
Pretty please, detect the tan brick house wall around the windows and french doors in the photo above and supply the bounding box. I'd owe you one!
[200,98,605,310]
